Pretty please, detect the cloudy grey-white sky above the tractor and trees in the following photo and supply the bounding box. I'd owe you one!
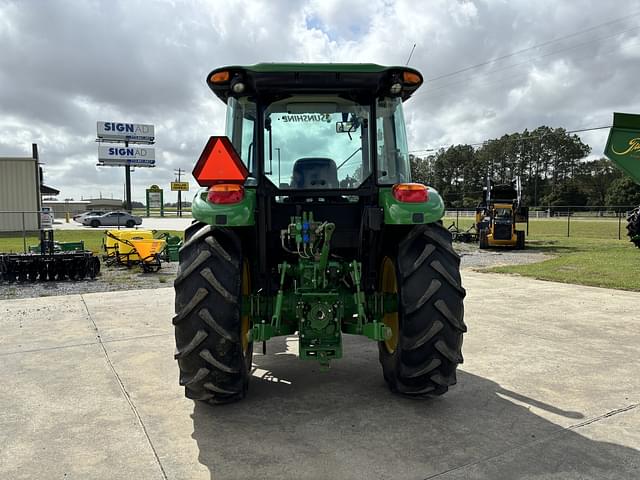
[0,0,640,200]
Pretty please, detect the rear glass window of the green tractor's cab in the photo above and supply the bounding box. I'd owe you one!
[264,98,370,189]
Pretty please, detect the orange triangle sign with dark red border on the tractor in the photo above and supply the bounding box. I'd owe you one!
[193,136,249,187]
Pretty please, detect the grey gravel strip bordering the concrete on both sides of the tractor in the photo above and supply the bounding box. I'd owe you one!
[0,243,550,300]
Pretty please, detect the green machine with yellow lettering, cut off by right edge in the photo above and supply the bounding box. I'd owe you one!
[604,113,640,248]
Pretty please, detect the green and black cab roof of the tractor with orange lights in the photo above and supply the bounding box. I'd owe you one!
[207,63,423,102]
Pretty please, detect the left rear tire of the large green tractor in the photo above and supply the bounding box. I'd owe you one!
[173,223,253,403]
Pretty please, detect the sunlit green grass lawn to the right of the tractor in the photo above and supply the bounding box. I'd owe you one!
[445,218,640,291]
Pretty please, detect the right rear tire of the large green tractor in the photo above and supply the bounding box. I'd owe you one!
[378,224,467,397]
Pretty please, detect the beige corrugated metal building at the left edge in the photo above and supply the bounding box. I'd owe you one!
[0,143,41,232]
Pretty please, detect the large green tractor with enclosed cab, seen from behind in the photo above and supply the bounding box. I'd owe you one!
[173,64,467,404]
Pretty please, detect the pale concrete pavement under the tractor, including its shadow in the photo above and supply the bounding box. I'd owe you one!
[0,271,640,480]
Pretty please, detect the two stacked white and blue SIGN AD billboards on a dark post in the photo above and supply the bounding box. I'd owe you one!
[96,122,158,215]
